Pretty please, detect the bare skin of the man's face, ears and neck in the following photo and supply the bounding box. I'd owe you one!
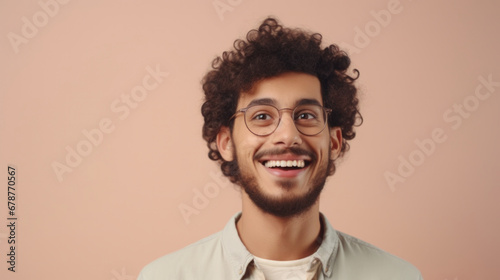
[217,72,342,260]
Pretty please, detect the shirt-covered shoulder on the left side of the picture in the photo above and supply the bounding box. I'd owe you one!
[138,232,222,280]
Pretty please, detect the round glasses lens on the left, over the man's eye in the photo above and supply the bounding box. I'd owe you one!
[245,105,280,135]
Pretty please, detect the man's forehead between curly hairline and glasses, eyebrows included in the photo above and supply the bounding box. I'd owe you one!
[238,72,323,108]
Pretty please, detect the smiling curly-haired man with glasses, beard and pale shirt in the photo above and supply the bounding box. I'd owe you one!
[139,18,422,280]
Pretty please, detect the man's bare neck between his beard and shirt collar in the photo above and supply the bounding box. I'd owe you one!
[236,192,321,261]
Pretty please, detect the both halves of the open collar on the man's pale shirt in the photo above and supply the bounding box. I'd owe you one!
[222,212,339,279]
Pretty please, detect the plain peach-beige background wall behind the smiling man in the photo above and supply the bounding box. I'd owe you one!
[0,0,500,280]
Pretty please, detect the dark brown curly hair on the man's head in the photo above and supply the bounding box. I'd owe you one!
[201,18,363,183]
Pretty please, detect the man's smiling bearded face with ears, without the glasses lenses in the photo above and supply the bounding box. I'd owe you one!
[217,73,341,217]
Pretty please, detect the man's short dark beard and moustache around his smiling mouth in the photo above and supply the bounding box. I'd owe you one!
[234,148,334,218]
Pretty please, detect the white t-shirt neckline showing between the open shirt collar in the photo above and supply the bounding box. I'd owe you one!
[254,255,313,280]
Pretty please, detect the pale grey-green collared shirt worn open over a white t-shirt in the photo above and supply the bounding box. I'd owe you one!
[138,213,422,280]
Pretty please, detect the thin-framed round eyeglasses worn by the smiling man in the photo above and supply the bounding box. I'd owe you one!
[231,104,332,136]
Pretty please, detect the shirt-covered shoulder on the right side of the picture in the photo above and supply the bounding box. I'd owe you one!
[336,231,422,280]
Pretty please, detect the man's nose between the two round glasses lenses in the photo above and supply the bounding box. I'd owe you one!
[271,110,302,147]
